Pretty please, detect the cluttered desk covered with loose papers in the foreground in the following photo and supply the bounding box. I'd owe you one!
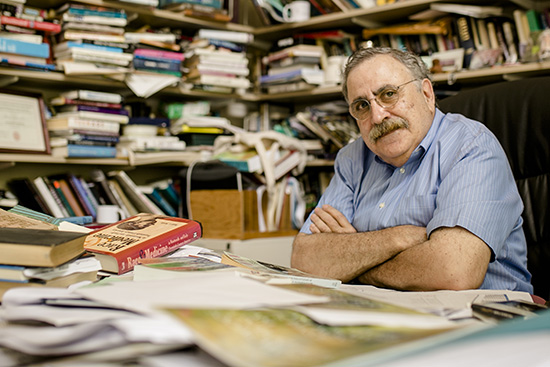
[0,207,550,367]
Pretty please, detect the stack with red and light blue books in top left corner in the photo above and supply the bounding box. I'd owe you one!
[0,2,61,71]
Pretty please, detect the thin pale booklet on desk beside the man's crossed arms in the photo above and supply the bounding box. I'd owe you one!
[221,252,342,288]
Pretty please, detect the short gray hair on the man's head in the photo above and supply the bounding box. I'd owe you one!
[342,47,431,102]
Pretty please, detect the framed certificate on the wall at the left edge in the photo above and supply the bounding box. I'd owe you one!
[0,89,50,154]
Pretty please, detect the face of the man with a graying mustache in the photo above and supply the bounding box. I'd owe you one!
[347,55,435,167]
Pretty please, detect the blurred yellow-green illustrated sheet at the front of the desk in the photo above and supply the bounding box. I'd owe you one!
[169,309,464,367]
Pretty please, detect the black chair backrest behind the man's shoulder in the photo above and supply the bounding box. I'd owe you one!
[439,77,550,299]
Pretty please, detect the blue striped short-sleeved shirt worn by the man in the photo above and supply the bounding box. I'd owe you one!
[301,110,533,293]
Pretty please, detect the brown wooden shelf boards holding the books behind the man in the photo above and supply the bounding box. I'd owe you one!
[0,0,550,207]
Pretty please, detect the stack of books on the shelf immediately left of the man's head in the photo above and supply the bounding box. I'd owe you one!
[260,44,324,94]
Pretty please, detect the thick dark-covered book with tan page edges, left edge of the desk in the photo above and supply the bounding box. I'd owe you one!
[0,228,86,267]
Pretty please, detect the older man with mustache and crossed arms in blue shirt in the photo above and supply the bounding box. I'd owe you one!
[292,48,532,292]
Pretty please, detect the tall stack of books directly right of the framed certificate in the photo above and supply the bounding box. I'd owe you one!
[47,90,129,158]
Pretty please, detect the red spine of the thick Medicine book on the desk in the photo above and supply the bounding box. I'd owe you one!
[116,222,202,274]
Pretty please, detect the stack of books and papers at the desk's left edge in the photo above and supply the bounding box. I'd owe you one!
[0,210,100,300]
